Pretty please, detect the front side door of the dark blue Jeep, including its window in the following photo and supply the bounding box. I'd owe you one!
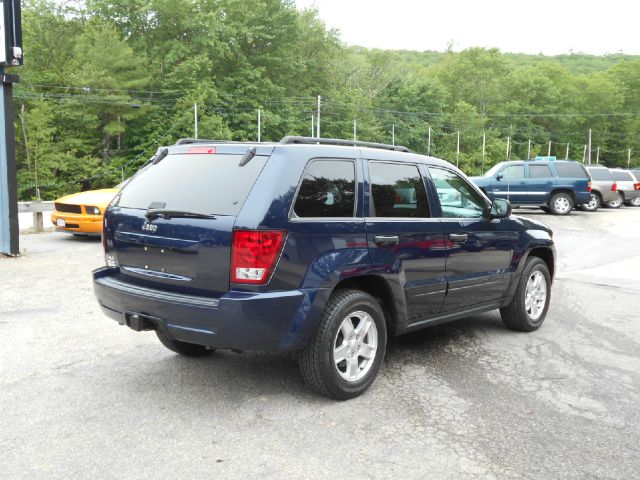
[428,166,518,312]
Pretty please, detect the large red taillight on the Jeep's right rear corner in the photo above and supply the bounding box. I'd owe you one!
[231,230,287,285]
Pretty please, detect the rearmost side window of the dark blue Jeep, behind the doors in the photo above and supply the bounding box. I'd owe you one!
[293,160,356,217]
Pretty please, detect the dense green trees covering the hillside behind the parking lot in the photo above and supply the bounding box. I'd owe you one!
[14,0,640,199]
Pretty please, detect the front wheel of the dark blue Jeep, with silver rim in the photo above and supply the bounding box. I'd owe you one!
[500,257,551,332]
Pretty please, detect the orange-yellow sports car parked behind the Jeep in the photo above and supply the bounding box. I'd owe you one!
[51,185,120,235]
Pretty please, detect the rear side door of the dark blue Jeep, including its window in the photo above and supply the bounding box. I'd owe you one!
[365,160,446,321]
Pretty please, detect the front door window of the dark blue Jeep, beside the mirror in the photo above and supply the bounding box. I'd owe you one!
[429,167,484,218]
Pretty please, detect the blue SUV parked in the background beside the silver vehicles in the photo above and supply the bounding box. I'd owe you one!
[472,157,591,215]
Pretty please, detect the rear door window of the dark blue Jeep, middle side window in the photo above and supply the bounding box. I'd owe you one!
[369,162,430,218]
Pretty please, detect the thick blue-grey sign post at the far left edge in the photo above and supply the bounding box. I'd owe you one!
[0,67,20,255]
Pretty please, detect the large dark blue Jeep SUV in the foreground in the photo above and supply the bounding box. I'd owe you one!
[94,137,555,399]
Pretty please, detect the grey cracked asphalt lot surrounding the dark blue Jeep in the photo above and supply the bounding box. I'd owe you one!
[0,208,640,480]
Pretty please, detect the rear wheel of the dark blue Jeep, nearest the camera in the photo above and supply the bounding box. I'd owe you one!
[300,289,387,400]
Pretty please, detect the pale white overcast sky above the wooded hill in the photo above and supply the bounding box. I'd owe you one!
[295,0,640,55]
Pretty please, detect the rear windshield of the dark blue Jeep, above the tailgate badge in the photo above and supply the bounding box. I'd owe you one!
[118,154,268,215]
